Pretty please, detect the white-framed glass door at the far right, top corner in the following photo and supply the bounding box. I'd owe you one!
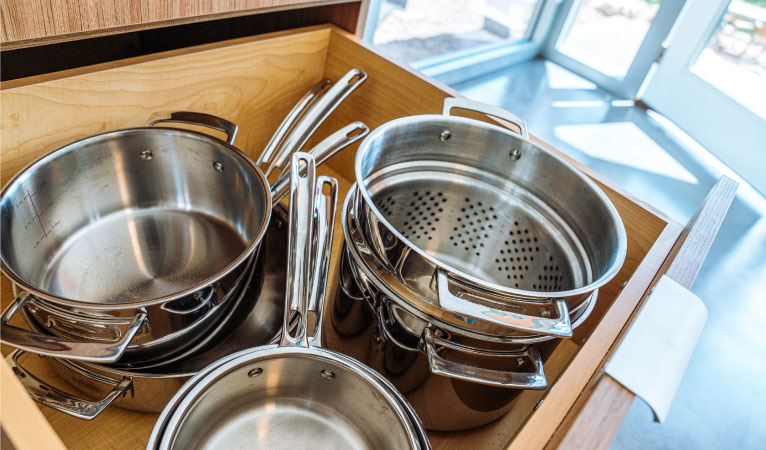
[642,0,766,193]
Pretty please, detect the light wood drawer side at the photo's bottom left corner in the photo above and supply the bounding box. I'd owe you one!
[0,359,65,450]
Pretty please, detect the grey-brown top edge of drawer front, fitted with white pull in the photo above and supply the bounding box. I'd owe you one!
[548,176,739,449]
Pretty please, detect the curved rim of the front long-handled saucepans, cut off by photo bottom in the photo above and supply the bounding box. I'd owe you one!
[154,344,422,449]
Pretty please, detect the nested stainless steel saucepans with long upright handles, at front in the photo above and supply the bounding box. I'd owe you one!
[149,154,428,449]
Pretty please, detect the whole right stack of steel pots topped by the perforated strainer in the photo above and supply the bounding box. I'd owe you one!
[325,99,627,430]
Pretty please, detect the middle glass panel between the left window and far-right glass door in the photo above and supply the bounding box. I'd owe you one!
[545,0,684,100]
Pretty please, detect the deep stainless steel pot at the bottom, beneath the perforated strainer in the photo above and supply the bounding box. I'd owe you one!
[324,185,596,430]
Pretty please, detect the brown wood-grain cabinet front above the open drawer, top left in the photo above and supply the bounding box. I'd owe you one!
[0,0,369,50]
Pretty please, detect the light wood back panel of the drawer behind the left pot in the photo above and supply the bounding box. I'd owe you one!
[0,27,330,185]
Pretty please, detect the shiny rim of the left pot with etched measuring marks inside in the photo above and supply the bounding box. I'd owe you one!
[0,127,272,311]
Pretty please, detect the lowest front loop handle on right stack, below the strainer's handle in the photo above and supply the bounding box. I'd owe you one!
[423,328,548,390]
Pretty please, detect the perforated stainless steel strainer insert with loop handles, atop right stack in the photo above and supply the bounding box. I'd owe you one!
[354,98,627,337]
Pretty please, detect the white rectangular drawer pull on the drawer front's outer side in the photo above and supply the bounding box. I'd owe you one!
[604,276,707,422]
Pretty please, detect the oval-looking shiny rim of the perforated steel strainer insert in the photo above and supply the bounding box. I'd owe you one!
[348,114,628,299]
